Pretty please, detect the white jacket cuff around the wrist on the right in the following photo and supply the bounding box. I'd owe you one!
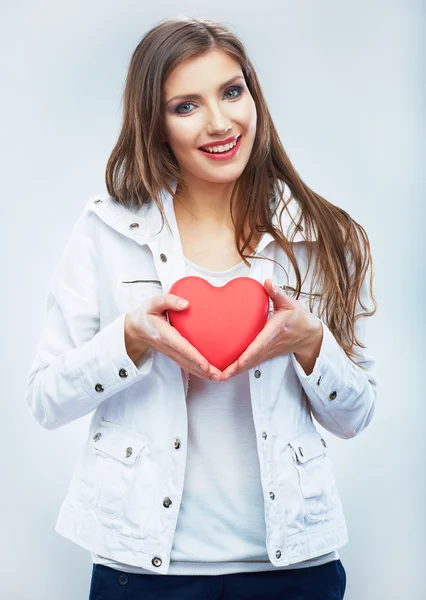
[291,319,349,409]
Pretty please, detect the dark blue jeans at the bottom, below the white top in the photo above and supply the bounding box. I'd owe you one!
[89,559,346,600]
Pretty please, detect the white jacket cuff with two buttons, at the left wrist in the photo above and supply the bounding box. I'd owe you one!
[77,313,155,403]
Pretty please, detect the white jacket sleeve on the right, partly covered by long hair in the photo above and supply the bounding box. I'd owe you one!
[291,260,377,439]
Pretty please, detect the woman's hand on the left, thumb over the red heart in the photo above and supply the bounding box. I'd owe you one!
[125,294,221,381]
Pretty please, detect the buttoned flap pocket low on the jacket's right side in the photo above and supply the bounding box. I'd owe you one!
[289,430,338,520]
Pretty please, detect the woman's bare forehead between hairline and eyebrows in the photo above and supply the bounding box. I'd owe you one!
[164,50,242,98]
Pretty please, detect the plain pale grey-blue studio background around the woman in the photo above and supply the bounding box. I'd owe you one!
[0,0,426,600]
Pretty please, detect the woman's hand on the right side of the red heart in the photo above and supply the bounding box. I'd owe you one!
[221,279,323,381]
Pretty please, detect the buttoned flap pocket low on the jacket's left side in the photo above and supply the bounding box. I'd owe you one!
[80,420,147,518]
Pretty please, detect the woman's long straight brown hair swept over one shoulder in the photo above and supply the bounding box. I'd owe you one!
[105,16,377,362]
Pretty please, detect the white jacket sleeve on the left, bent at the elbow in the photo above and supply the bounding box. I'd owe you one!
[26,209,154,429]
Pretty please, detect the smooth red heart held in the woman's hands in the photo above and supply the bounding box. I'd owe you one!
[168,276,269,371]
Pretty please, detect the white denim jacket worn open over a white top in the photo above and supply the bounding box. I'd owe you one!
[26,182,377,574]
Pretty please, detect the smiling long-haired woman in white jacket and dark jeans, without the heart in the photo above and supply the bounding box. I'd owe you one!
[27,17,377,600]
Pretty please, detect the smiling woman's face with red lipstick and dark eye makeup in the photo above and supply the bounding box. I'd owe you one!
[164,50,257,183]
